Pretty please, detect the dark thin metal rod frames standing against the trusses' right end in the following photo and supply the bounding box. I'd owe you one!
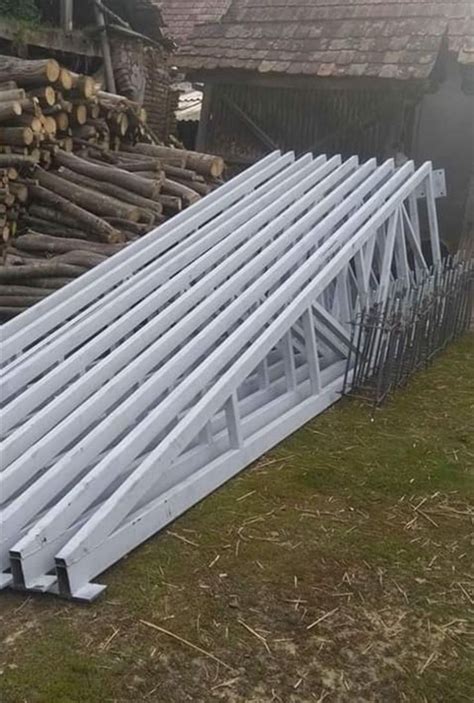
[344,256,474,405]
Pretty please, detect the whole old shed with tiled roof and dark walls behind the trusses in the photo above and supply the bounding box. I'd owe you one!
[179,0,474,246]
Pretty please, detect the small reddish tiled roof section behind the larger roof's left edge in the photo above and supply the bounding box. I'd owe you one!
[159,0,231,43]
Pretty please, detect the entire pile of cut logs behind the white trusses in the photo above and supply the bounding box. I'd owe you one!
[0,57,224,322]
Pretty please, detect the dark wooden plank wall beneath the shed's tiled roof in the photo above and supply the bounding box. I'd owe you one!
[206,83,414,162]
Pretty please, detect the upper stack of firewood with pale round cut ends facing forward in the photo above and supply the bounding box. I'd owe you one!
[0,56,146,164]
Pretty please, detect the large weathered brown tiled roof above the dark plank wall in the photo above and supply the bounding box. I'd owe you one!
[179,0,474,79]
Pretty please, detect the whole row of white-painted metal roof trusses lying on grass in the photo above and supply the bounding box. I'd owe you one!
[0,153,440,600]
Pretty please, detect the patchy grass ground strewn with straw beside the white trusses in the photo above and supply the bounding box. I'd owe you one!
[0,335,474,703]
